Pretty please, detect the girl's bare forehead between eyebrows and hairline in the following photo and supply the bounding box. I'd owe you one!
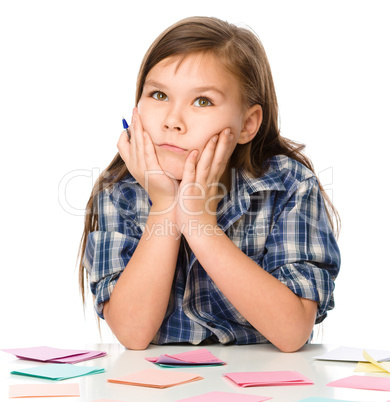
[146,53,239,91]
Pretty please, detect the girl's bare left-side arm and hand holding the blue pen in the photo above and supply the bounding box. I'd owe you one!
[103,111,181,349]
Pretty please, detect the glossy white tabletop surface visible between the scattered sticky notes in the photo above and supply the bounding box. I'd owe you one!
[0,344,390,402]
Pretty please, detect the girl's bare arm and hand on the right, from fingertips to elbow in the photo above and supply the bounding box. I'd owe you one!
[178,130,330,352]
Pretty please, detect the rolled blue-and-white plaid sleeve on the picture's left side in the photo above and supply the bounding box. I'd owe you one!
[83,187,141,318]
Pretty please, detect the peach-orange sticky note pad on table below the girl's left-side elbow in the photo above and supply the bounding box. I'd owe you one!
[107,369,203,388]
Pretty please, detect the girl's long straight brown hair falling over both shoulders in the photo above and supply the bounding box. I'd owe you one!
[79,17,339,300]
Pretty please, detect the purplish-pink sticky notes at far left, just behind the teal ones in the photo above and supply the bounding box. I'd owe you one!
[1,346,107,363]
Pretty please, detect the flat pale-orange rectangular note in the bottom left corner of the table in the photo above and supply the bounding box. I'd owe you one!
[9,384,80,398]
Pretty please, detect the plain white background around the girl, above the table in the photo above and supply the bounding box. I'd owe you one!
[0,0,390,349]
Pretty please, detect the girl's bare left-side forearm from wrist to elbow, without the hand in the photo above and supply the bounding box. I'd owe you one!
[103,207,180,349]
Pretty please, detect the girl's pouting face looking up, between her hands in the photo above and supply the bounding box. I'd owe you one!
[138,54,244,180]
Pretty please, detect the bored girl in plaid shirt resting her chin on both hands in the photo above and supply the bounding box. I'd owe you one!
[80,17,340,352]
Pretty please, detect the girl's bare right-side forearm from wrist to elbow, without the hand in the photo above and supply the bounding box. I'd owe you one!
[187,231,317,352]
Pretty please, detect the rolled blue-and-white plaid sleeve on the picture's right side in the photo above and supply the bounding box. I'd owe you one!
[262,177,340,323]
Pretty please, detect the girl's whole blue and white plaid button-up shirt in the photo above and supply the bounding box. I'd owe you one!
[83,156,340,344]
